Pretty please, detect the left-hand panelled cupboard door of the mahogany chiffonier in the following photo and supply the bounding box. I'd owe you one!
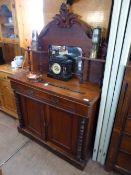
[20,96,45,138]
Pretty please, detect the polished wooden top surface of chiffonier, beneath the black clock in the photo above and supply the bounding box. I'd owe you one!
[9,70,101,105]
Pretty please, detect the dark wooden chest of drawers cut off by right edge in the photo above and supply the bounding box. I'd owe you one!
[106,64,131,175]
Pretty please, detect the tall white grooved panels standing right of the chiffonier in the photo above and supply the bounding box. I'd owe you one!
[93,0,131,164]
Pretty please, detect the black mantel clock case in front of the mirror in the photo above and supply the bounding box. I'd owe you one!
[47,56,72,81]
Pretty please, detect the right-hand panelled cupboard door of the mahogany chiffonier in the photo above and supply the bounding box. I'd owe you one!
[47,106,79,154]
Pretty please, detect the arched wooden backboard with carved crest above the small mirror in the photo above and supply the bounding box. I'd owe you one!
[38,3,92,57]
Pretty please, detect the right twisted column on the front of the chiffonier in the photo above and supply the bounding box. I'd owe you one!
[76,118,86,161]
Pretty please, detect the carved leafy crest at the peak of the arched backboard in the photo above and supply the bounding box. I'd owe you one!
[54,3,78,28]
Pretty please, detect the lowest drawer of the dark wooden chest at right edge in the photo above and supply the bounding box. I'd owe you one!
[116,152,131,173]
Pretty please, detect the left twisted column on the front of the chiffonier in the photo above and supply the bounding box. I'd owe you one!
[14,91,24,128]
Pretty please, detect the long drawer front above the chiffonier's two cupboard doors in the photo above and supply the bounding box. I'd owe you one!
[12,84,88,116]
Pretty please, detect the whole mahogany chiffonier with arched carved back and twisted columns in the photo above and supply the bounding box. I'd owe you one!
[10,4,105,169]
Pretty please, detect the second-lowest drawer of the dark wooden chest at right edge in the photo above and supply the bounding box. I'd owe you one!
[120,135,131,154]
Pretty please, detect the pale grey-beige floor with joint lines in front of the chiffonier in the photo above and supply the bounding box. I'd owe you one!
[0,112,118,175]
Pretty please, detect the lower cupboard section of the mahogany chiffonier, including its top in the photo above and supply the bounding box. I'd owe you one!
[10,71,100,169]
